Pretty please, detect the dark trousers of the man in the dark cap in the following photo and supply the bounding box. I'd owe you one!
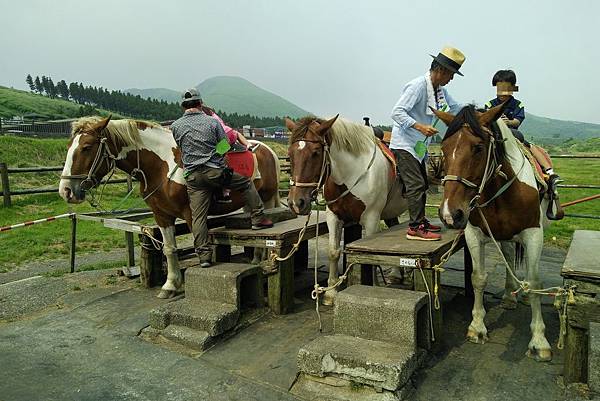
[186,167,264,262]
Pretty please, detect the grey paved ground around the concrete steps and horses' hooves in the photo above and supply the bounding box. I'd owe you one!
[0,234,592,400]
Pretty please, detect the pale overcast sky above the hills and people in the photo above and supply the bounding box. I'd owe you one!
[0,0,600,125]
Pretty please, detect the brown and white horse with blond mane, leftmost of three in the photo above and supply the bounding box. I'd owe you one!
[59,117,280,298]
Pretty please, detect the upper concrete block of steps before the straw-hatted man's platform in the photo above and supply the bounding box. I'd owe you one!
[334,285,431,351]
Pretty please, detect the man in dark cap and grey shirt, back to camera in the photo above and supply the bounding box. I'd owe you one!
[171,88,273,267]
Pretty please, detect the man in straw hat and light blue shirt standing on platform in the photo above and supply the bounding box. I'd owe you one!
[390,47,465,241]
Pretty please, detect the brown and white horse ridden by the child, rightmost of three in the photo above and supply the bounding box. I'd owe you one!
[434,105,552,361]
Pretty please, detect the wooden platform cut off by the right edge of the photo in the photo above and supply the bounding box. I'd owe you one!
[560,230,600,383]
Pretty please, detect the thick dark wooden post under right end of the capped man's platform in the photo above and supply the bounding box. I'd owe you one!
[268,242,294,315]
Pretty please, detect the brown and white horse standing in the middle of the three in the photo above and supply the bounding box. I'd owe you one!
[286,116,407,304]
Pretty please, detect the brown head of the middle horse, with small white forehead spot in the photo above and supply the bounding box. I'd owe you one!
[285,116,338,215]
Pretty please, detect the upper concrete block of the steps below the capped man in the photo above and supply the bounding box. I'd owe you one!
[185,263,263,309]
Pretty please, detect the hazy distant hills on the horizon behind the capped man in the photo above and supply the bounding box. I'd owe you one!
[125,77,309,118]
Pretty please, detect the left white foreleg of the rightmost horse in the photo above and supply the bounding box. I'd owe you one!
[465,224,488,344]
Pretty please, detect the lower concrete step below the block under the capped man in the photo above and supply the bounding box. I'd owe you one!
[150,298,240,337]
